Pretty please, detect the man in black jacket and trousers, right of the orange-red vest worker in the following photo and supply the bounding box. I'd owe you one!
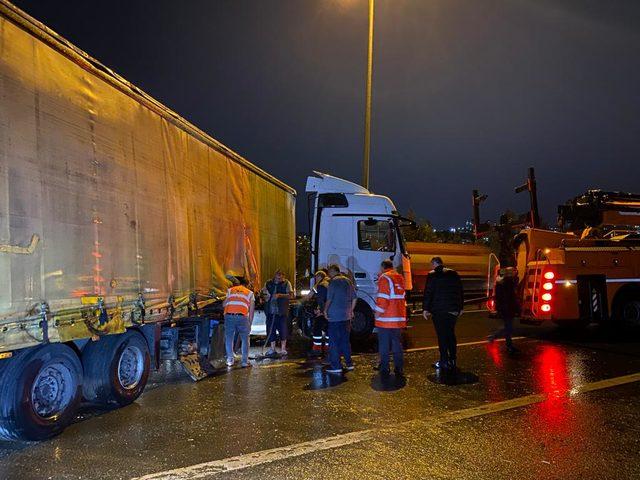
[422,257,464,370]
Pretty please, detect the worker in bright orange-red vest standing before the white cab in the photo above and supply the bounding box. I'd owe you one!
[376,259,407,376]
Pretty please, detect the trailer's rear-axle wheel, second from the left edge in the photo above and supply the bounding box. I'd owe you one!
[82,330,151,406]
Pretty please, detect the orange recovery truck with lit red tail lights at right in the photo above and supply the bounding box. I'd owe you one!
[474,168,640,328]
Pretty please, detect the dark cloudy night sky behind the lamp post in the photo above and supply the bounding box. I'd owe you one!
[10,0,640,230]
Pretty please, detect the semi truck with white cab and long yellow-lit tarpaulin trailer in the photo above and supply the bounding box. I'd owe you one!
[0,0,410,440]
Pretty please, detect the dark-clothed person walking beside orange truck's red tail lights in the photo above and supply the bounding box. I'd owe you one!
[487,267,520,355]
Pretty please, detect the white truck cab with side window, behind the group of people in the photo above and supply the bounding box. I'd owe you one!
[306,172,411,338]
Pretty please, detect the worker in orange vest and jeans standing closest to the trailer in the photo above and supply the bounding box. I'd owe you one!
[223,278,255,368]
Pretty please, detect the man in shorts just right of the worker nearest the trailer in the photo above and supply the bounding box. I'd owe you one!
[262,270,293,357]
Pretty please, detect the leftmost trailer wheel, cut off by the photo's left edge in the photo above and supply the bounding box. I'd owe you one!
[0,343,82,441]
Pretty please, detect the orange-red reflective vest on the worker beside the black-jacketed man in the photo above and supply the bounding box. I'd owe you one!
[376,269,407,328]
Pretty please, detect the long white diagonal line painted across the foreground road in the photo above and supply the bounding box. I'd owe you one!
[132,373,640,480]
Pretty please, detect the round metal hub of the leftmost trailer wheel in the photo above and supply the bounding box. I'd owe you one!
[31,362,75,418]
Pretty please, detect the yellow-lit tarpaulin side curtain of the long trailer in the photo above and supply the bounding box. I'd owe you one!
[0,0,295,350]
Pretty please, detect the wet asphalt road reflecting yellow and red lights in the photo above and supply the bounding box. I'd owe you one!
[0,313,640,480]
